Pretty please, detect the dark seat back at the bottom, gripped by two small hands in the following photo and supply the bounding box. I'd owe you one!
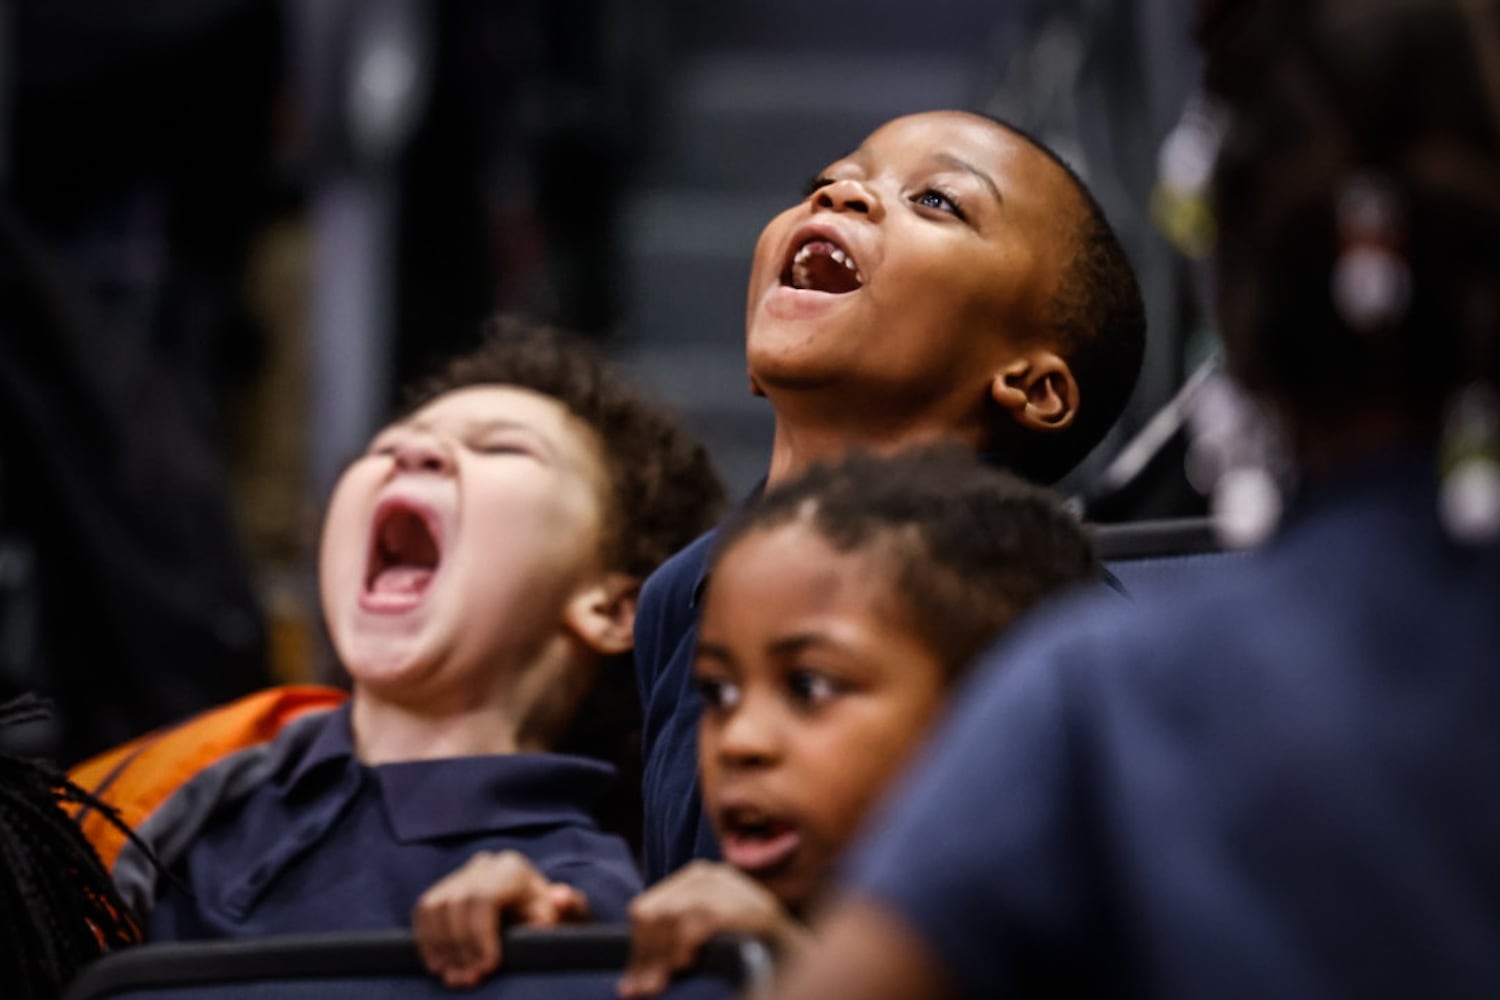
[65,925,771,1000]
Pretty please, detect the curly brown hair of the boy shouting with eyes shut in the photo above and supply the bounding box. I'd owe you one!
[407,316,725,577]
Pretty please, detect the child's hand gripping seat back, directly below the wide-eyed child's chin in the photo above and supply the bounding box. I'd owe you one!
[620,861,807,999]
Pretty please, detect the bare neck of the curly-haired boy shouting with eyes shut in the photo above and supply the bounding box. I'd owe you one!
[350,636,594,766]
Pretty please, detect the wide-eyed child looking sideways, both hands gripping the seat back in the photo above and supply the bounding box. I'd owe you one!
[414,445,1097,996]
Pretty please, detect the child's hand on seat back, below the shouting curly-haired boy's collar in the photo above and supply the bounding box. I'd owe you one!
[411,850,590,987]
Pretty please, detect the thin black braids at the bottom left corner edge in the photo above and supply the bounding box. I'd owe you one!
[0,697,141,1000]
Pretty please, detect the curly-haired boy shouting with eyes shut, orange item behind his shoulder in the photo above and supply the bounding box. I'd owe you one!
[75,331,722,940]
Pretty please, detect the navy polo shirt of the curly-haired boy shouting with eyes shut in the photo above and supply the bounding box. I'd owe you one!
[149,706,641,940]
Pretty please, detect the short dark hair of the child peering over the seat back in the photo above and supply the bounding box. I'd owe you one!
[708,444,1101,676]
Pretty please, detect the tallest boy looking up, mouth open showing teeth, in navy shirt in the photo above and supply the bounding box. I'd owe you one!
[636,111,1145,882]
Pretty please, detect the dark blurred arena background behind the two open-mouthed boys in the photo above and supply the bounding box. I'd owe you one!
[0,0,1214,762]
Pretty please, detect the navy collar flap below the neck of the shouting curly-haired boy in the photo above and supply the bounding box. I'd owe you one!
[371,754,615,843]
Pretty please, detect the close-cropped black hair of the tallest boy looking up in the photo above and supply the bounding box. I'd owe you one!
[992,118,1146,483]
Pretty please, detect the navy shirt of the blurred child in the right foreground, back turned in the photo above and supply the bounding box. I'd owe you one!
[848,453,1500,999]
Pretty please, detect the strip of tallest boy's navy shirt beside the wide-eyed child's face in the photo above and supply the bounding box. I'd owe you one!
[636,531,719,883]
